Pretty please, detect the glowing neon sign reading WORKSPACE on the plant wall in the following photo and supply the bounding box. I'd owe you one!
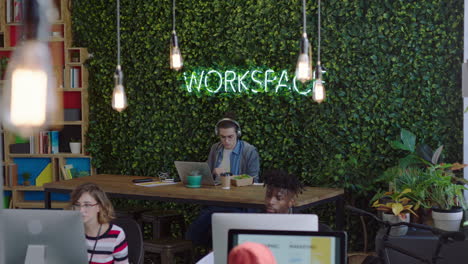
[183,69,320,95]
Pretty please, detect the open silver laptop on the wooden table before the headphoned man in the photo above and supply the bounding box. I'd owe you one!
[174,161,220,186]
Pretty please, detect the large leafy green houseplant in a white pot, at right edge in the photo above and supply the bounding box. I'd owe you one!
[377,129,466,229]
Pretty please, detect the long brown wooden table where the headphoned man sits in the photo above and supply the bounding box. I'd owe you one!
[44,174,344,230]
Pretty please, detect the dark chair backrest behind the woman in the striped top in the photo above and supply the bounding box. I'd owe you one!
[112,218,145,264]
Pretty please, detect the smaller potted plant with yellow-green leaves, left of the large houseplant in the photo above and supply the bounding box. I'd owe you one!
[371,189,417,236]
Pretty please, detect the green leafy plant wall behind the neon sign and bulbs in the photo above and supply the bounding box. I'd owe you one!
[72,0,463,251]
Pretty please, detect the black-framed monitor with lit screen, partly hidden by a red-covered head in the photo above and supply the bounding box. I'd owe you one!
[228,229,347,264]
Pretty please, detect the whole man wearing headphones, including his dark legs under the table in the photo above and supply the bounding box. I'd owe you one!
[186,115,260,247]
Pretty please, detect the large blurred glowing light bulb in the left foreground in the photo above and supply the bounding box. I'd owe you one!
[2,0,63,137]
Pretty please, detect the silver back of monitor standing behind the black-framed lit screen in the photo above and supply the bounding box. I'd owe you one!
[211,213,318,264]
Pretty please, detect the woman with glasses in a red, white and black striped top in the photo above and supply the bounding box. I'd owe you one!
[71,183,128,264]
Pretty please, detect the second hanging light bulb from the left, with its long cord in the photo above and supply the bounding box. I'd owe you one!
[112,0,127,112]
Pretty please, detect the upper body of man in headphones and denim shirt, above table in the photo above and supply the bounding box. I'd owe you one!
[208,118,260,182]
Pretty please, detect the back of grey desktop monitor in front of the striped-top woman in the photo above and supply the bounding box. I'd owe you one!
[0,209,88,264]
